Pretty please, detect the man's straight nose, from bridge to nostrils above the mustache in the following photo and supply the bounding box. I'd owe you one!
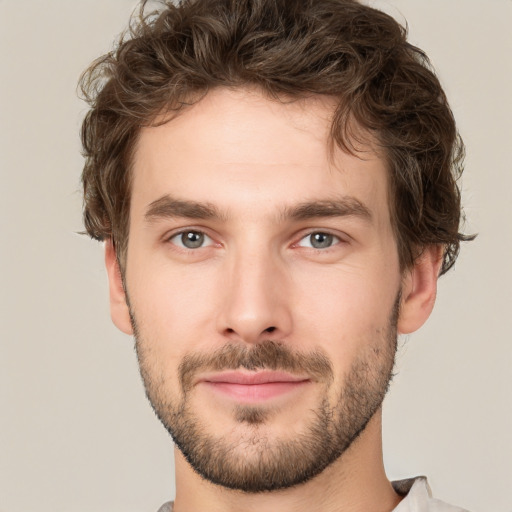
[218,244,292,344]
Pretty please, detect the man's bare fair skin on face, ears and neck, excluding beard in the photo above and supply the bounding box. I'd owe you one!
[106,89,442,512]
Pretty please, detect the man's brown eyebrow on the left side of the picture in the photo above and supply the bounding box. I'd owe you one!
[144,194,224,223]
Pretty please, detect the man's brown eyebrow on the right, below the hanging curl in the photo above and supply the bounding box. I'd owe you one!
[283,196,372,222]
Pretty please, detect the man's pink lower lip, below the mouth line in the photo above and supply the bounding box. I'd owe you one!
[204,380,309,403]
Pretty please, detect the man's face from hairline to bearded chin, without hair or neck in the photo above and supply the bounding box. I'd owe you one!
[107,89,438,492]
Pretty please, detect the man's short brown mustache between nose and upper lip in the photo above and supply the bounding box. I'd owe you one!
[178,340,334,392]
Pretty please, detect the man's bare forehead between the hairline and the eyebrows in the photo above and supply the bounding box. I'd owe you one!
[132,88,387,222]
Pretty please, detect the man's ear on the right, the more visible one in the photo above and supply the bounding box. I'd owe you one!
[398,245,444,334]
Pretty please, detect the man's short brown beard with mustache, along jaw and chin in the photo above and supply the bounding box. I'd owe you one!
[132,296,400,493]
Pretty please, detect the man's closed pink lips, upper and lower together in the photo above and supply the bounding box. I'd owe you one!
[197,370,311,404]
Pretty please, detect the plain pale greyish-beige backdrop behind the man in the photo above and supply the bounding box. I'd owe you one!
[0,0,512,512]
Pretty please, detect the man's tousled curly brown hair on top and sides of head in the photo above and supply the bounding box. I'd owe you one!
[80,0,473,274]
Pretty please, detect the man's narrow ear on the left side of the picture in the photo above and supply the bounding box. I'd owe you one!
[105,240,133,334]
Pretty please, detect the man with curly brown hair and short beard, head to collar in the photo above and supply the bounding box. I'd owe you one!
[78,0,469,512]
